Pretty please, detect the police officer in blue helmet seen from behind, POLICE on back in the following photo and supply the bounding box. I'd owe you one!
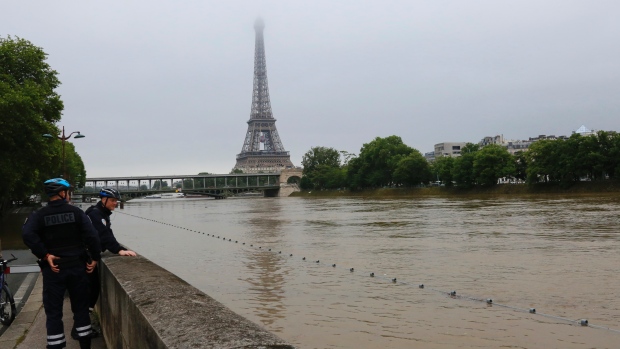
[22,178,100,349]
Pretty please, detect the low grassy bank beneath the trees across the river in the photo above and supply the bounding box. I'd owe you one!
[291,181,620,197]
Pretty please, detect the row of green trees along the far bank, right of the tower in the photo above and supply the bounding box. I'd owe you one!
[300,131,620,192]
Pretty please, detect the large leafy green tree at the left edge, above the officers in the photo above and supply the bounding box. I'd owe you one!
[0,36,64,202]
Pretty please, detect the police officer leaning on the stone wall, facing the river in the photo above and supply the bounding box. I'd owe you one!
[86,188,136,308]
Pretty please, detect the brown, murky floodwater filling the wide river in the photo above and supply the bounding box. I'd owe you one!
[100,195,620,349]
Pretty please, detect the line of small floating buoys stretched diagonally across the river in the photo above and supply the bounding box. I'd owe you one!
[117,211,620,333]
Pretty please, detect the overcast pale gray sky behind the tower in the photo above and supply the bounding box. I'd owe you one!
[0,0,620,177]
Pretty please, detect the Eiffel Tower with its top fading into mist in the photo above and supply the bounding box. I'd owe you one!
[233,18,294,173]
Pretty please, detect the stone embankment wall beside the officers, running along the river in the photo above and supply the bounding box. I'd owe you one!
[98,254,294,349]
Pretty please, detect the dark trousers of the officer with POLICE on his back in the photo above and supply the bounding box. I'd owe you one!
[41,264,91,349]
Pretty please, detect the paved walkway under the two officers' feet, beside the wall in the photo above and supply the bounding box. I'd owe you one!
[0,274,106,349]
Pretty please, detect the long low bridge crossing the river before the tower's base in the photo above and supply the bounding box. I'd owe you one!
[74,168,302,199]
